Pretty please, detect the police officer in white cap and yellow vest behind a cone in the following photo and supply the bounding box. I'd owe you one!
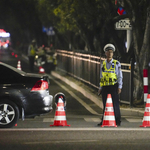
[98,44,123,126]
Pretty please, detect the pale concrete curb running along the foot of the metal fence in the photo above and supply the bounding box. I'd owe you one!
[51,71,144,117]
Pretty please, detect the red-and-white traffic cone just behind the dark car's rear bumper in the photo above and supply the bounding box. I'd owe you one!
[50,97,70,126]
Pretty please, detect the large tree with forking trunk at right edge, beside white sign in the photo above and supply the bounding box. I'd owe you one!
[118,0,150,100]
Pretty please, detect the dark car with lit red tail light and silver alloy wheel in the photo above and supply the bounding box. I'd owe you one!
[0,62,53,128]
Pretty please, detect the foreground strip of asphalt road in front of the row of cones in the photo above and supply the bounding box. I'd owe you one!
[0,128,150,150]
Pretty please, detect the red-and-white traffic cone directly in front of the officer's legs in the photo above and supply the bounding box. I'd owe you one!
[101,94,117,127]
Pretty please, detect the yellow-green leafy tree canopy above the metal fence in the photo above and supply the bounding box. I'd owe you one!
[36,0,132,56]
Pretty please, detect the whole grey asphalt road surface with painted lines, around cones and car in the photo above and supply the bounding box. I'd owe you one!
[0,48,150,150]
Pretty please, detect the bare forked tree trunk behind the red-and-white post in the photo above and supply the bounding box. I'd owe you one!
[134,7,150,100]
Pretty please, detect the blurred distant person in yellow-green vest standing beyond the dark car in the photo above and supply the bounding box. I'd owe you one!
[28,40,37,72]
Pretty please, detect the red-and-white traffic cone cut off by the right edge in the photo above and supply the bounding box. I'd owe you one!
[140,94,150,127]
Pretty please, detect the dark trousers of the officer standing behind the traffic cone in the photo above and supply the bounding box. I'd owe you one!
[102,83,121,124]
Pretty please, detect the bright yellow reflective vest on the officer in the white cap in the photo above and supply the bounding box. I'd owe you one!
[100,60,117,87]
